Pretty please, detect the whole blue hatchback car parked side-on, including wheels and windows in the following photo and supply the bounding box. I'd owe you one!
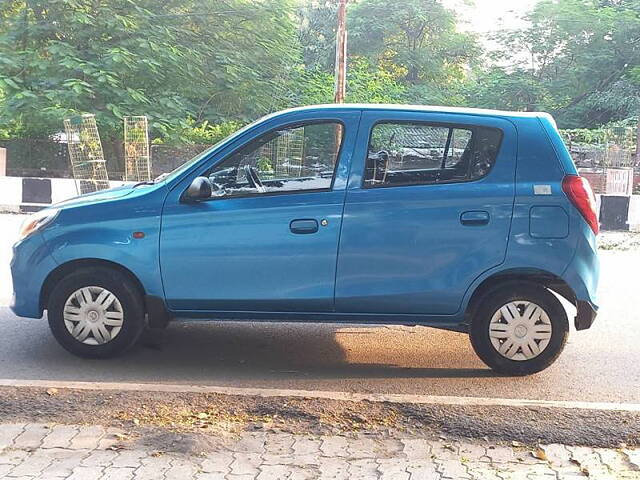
[11,105,599,375]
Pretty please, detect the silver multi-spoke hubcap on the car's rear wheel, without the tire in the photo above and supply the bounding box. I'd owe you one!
[489,300,553,361]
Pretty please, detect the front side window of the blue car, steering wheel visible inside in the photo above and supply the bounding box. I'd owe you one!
[206,122,343,197]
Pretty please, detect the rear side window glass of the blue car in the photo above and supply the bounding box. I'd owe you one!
[364,122,502,188]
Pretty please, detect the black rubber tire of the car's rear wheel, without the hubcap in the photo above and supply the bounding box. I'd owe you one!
[469,282,569,375]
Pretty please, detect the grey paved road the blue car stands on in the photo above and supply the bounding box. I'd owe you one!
[0,215,640,403]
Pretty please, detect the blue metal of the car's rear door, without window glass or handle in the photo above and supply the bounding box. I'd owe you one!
[336,111,517,315]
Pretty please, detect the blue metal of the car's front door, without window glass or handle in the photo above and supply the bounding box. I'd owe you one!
[160,110,360,312]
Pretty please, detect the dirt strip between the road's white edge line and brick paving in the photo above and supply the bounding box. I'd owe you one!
[0,387,640,453]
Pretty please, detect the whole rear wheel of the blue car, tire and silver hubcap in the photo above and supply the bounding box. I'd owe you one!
[470,283,569,375]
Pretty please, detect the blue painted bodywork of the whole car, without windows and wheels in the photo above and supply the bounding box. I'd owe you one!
[12,105,598,330]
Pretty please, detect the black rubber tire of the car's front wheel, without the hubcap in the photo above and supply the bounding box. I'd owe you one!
[47,267,145,358]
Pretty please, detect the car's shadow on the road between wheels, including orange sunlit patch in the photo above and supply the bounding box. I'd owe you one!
[124,322,495,379]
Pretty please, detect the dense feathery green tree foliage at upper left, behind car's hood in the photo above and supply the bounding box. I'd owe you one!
[0,0,299,137]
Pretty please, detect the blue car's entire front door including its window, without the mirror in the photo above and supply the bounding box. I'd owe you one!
[160,112,359,312]
